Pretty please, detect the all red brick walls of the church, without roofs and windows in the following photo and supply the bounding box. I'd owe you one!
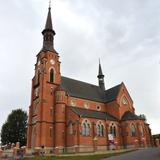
[27,52,151,151]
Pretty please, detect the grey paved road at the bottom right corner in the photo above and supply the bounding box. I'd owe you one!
[103,148,160,160]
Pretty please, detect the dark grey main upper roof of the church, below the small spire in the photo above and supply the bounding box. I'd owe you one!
[61,76,121,103]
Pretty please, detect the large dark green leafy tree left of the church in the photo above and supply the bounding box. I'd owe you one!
[1,109,27,146]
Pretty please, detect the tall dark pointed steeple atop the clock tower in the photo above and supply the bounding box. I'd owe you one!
[42,4,56,52]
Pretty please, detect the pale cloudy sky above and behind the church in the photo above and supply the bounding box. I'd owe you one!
[0,0,160,134]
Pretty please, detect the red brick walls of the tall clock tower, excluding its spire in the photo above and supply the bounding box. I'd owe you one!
[27,52,61,148]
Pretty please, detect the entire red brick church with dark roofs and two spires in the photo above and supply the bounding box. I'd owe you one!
[27,7,151,153]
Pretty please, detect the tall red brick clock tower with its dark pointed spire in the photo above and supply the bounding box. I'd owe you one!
[27,6,61,149]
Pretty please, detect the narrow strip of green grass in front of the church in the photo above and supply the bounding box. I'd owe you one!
[25,151,135,160]
